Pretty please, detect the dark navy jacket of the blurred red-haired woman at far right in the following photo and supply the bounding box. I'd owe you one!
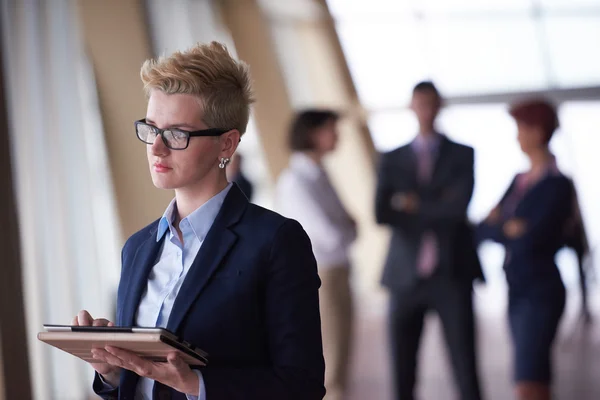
[476,175,573,291]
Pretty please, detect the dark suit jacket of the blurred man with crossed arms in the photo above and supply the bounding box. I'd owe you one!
[375,136,483,289]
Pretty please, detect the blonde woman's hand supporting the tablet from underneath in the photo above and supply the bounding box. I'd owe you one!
[92,346,200,396]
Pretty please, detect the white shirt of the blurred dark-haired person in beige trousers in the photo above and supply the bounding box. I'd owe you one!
[276,152,356,268]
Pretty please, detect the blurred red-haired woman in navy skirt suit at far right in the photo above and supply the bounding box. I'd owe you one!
[477,100,579,400]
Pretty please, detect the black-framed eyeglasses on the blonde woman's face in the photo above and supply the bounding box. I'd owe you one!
[135,119,231,150]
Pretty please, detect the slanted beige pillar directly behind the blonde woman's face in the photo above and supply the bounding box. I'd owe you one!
[79,0,173,238]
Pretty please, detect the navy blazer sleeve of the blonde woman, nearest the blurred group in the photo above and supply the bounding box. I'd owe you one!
[202,220,325,400]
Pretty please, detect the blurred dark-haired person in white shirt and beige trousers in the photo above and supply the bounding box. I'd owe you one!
[276,110,356,400]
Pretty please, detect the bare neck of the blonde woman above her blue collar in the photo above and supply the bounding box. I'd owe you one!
[175,171,229,222]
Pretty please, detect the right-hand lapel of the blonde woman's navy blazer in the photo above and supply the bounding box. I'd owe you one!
[167,184,248,332]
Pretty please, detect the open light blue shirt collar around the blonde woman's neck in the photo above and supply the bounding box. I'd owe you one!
[156,182,233,242]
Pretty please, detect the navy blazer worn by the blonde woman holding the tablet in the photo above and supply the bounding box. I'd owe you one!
[94,185,325,400]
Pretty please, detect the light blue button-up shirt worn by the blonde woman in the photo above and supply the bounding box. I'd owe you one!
[135,183,232,400]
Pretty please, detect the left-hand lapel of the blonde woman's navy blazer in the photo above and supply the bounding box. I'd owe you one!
[117,228,166,326]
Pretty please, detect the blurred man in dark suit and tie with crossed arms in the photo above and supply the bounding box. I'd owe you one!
[376,82,483,400]
